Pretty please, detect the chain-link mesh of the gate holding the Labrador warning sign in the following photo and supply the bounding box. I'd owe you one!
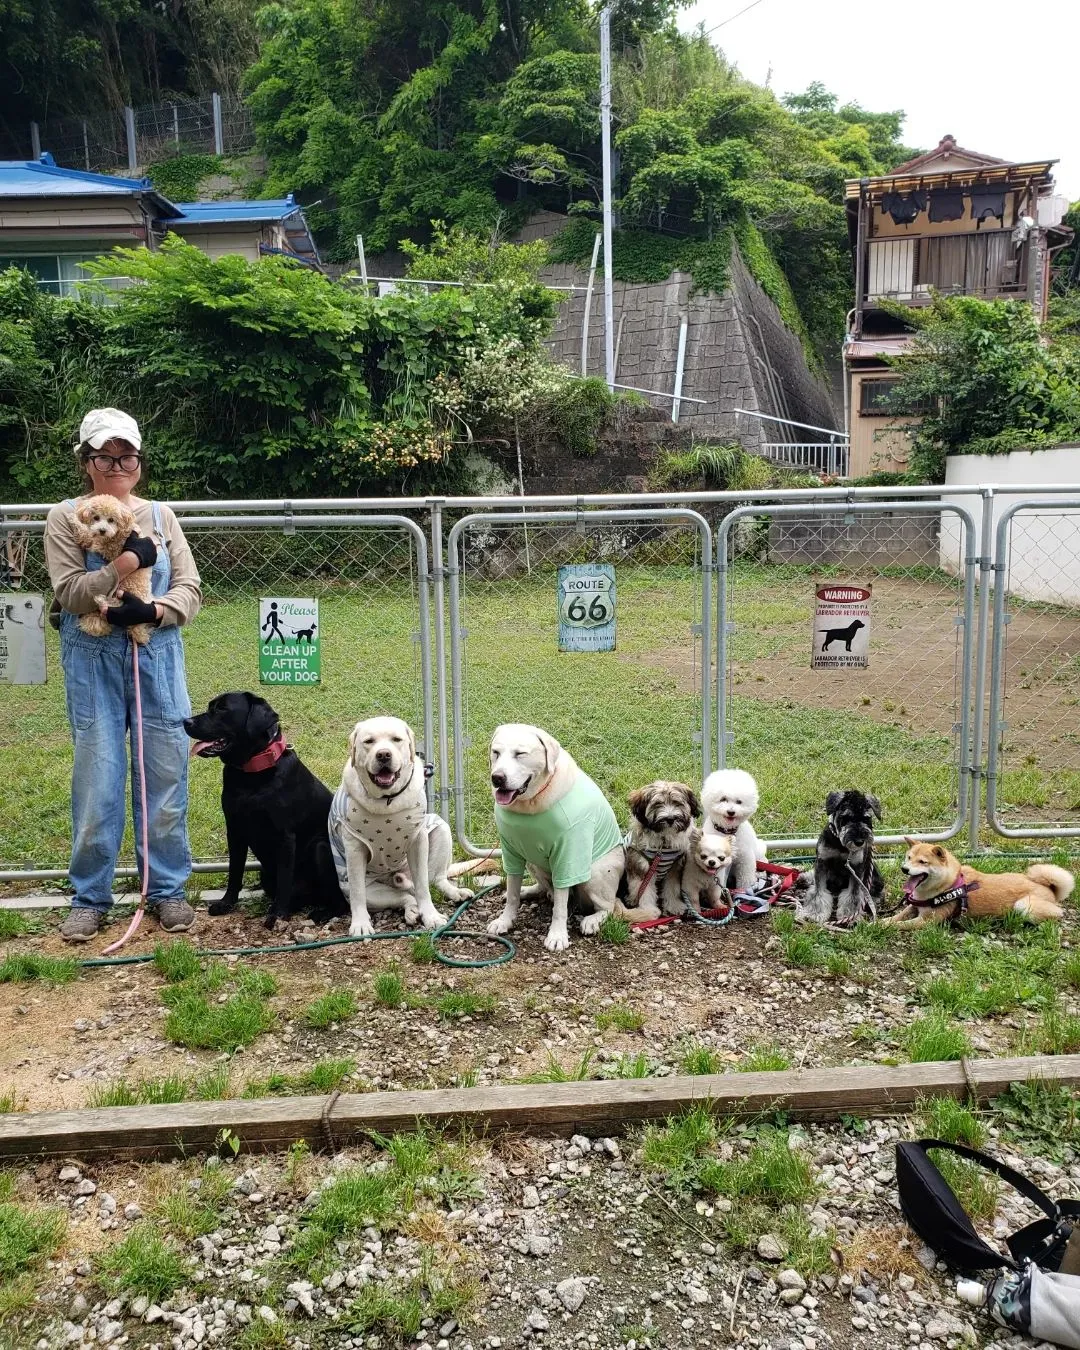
[717,501,975,844]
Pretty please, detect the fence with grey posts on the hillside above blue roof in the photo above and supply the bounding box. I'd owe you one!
[20,93,255,174]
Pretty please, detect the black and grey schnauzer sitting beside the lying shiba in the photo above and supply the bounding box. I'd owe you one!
[795,788,886,927]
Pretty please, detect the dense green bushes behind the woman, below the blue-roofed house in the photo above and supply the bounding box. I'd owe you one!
[0,238,568,501]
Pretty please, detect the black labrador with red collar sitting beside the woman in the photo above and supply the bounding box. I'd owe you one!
[184,693,348,929]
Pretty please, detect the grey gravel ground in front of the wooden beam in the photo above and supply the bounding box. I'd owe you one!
[0,1121,1080,1350]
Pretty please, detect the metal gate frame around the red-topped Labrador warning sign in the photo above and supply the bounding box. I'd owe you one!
[716,497,979,848]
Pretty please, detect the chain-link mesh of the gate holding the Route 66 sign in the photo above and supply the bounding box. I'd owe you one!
[447,510,711,851]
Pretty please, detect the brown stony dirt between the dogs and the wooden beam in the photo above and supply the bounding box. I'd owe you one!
[0,880,1076,1110]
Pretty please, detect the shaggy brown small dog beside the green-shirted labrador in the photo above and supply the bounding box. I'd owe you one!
[616,780,701,923]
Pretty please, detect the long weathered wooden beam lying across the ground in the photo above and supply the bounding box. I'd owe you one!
[0,1054,1080,1161]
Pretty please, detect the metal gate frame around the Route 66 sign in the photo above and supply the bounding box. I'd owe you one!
[436,508,713,857]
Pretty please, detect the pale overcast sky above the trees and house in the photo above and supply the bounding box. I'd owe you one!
[679,0,1080,201]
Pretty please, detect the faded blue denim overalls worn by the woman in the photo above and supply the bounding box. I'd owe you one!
[59,501,192,910]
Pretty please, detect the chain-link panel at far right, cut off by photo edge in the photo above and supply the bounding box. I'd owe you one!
[987,498,1080,838]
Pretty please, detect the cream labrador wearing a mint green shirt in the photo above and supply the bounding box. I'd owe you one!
[487,722,625,952]
